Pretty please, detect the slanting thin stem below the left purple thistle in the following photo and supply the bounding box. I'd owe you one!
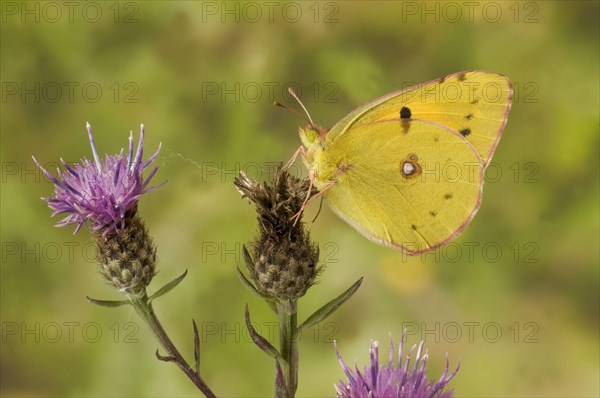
[131,293,216,398]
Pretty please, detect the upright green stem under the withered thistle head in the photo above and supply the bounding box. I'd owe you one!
[275,300,298,398]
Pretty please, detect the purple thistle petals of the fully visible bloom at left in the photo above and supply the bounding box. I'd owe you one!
[32,123,166,236]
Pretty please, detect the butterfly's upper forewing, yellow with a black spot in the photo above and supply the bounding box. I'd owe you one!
[326,71,512,167]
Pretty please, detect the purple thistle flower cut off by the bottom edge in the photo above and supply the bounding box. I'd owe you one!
[334,331,460,398]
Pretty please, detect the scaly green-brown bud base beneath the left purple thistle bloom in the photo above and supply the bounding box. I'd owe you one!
[95,214,156,296]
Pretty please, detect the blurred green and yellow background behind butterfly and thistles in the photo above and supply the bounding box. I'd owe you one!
[0,1,600,397]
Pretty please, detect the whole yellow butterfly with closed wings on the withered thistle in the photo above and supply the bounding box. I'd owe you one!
[290,71,513,254]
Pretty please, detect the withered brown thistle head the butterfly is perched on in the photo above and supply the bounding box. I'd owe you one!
[235,166,320,301]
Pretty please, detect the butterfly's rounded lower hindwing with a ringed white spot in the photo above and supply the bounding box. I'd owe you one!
[316,118,483,254]
